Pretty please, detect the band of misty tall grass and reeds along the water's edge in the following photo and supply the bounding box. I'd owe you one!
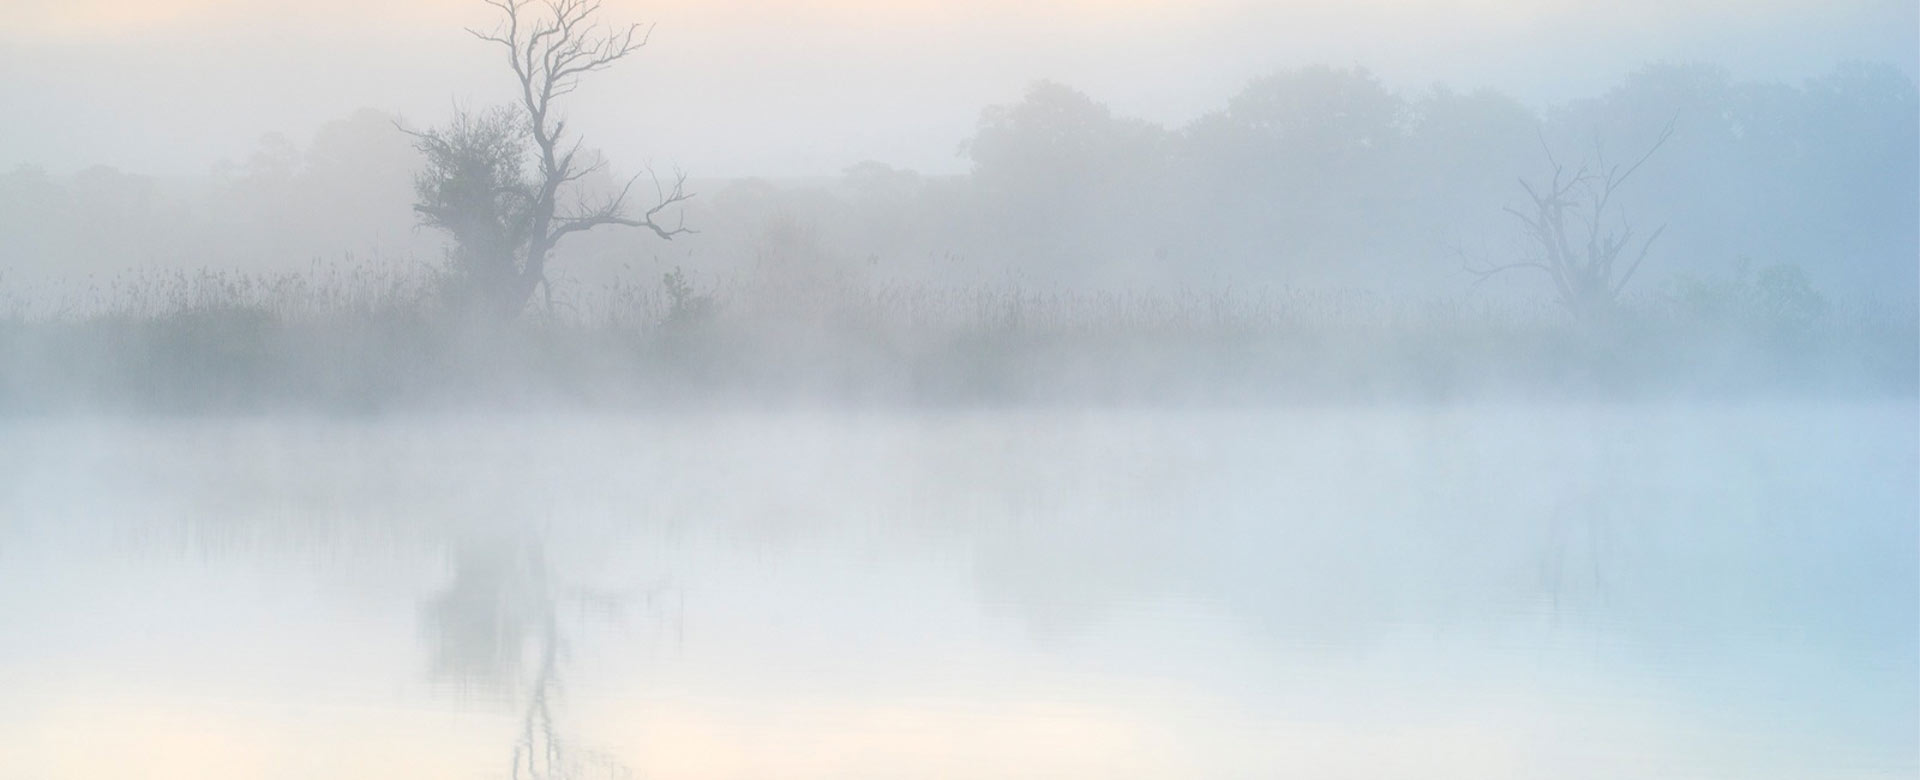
[0,261,1920,413]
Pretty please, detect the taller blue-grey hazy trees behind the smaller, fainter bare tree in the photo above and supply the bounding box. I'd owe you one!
[890,63,1920,301]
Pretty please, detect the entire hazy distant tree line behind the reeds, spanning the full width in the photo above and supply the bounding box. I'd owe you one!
[0,63,1920,307]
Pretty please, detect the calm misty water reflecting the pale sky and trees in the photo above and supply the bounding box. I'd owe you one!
[0,403,1920,780]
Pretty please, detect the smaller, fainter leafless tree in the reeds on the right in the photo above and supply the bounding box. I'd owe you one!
[1467,121,1674,321]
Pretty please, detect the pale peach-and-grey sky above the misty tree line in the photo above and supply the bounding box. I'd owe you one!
[0,0,1920,177]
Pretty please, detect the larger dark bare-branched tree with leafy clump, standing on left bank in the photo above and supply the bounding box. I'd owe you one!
[413,0,693,319]
